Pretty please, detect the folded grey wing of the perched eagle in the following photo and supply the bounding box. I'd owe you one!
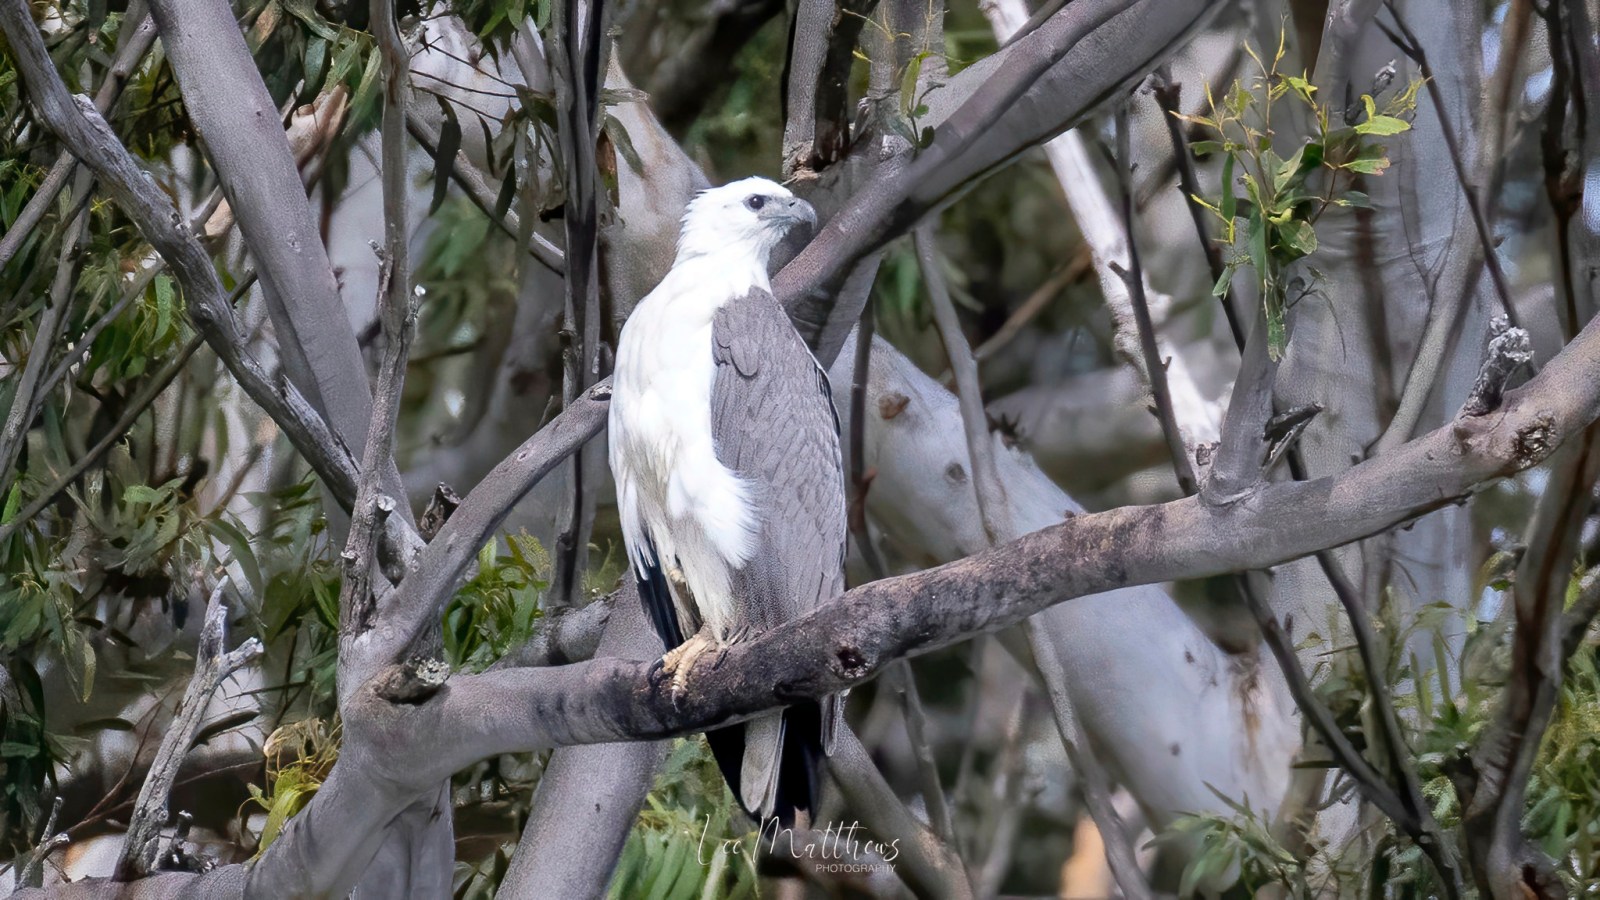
[710,290,848,631]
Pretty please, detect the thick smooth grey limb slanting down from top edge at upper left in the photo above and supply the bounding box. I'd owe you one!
[150,0,396,496]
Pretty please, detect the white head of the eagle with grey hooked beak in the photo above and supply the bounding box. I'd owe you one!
[678,178,816,267]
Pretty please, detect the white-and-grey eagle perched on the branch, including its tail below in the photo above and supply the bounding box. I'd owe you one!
[610,178,846,825]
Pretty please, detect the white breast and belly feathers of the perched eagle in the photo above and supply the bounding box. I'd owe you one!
[610,255,770,637]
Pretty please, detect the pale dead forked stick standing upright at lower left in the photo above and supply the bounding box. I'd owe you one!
[115,577,262,881]
